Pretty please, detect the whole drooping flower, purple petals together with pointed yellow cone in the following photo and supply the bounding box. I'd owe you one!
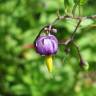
[35,35,58,72]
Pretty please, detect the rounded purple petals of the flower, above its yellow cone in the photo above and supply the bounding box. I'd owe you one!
[35,35,58,55]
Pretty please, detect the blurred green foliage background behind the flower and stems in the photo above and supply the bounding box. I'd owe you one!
[0,0,96,96]
